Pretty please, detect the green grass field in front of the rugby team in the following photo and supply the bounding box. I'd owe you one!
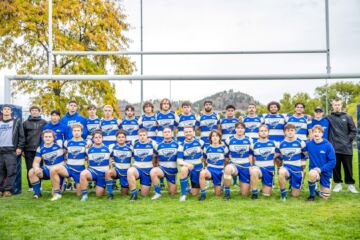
[0,151,360,240]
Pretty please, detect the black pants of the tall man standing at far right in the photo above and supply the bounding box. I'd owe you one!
[333,153,355,184]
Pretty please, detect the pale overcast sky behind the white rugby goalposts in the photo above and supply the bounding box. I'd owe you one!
[0,0,360,105]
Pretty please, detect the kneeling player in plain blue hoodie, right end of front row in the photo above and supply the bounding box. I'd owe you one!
[306,125,336,201]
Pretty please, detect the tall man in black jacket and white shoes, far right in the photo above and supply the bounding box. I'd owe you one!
[328,99,358,193]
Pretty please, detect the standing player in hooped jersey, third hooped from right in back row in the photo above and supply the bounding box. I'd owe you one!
[242,103,264,142]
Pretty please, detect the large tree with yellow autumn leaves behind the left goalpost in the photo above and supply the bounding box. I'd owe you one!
[0,0,135,114]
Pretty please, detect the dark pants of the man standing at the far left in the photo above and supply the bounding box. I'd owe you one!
[0,151,17,192]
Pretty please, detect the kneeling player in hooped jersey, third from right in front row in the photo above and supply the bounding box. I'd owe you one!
[250,125,277,199]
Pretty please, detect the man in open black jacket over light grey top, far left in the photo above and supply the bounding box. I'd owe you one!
[0,105,25,197]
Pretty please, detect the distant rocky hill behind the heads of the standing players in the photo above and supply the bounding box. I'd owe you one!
[119,89,259,115]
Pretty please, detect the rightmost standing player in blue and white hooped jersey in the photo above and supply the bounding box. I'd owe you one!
[286,103,311,141]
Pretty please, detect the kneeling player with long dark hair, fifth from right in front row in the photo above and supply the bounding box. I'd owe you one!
[199,130,229,201]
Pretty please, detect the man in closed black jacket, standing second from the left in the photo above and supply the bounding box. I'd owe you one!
[23,106,47,191]
